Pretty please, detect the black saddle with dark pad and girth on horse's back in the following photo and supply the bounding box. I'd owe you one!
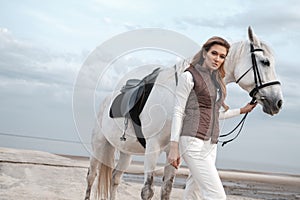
[109,68,160,147]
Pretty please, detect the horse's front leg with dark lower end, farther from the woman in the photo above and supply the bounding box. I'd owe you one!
[141,140,160,200]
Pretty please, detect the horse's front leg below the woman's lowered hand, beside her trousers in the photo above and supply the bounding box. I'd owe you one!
[160,154,176,200]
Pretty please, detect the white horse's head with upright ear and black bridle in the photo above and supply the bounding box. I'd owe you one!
[225,27,283,115]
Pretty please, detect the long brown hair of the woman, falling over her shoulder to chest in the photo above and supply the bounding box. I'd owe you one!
[191,36,230,109]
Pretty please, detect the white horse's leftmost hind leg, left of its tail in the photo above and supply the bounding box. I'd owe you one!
[84,157,99,200]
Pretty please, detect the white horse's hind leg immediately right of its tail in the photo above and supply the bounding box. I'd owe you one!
[110,152,131,200]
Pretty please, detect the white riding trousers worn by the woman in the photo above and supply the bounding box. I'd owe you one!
[179,136,226,200]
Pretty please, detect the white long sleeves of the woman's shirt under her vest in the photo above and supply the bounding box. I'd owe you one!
[170,71,240,142]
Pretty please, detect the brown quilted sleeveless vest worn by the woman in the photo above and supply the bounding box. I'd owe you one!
[181,64,223,143]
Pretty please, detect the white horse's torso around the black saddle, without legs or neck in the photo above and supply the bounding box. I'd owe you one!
[98,69,176,154]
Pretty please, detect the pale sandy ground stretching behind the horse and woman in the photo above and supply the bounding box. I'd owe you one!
[0,148,300,200]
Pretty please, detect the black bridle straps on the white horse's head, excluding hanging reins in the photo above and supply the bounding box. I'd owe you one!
[236,43,280,101]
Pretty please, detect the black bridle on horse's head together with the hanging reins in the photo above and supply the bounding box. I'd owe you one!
[219,43,280,146]
